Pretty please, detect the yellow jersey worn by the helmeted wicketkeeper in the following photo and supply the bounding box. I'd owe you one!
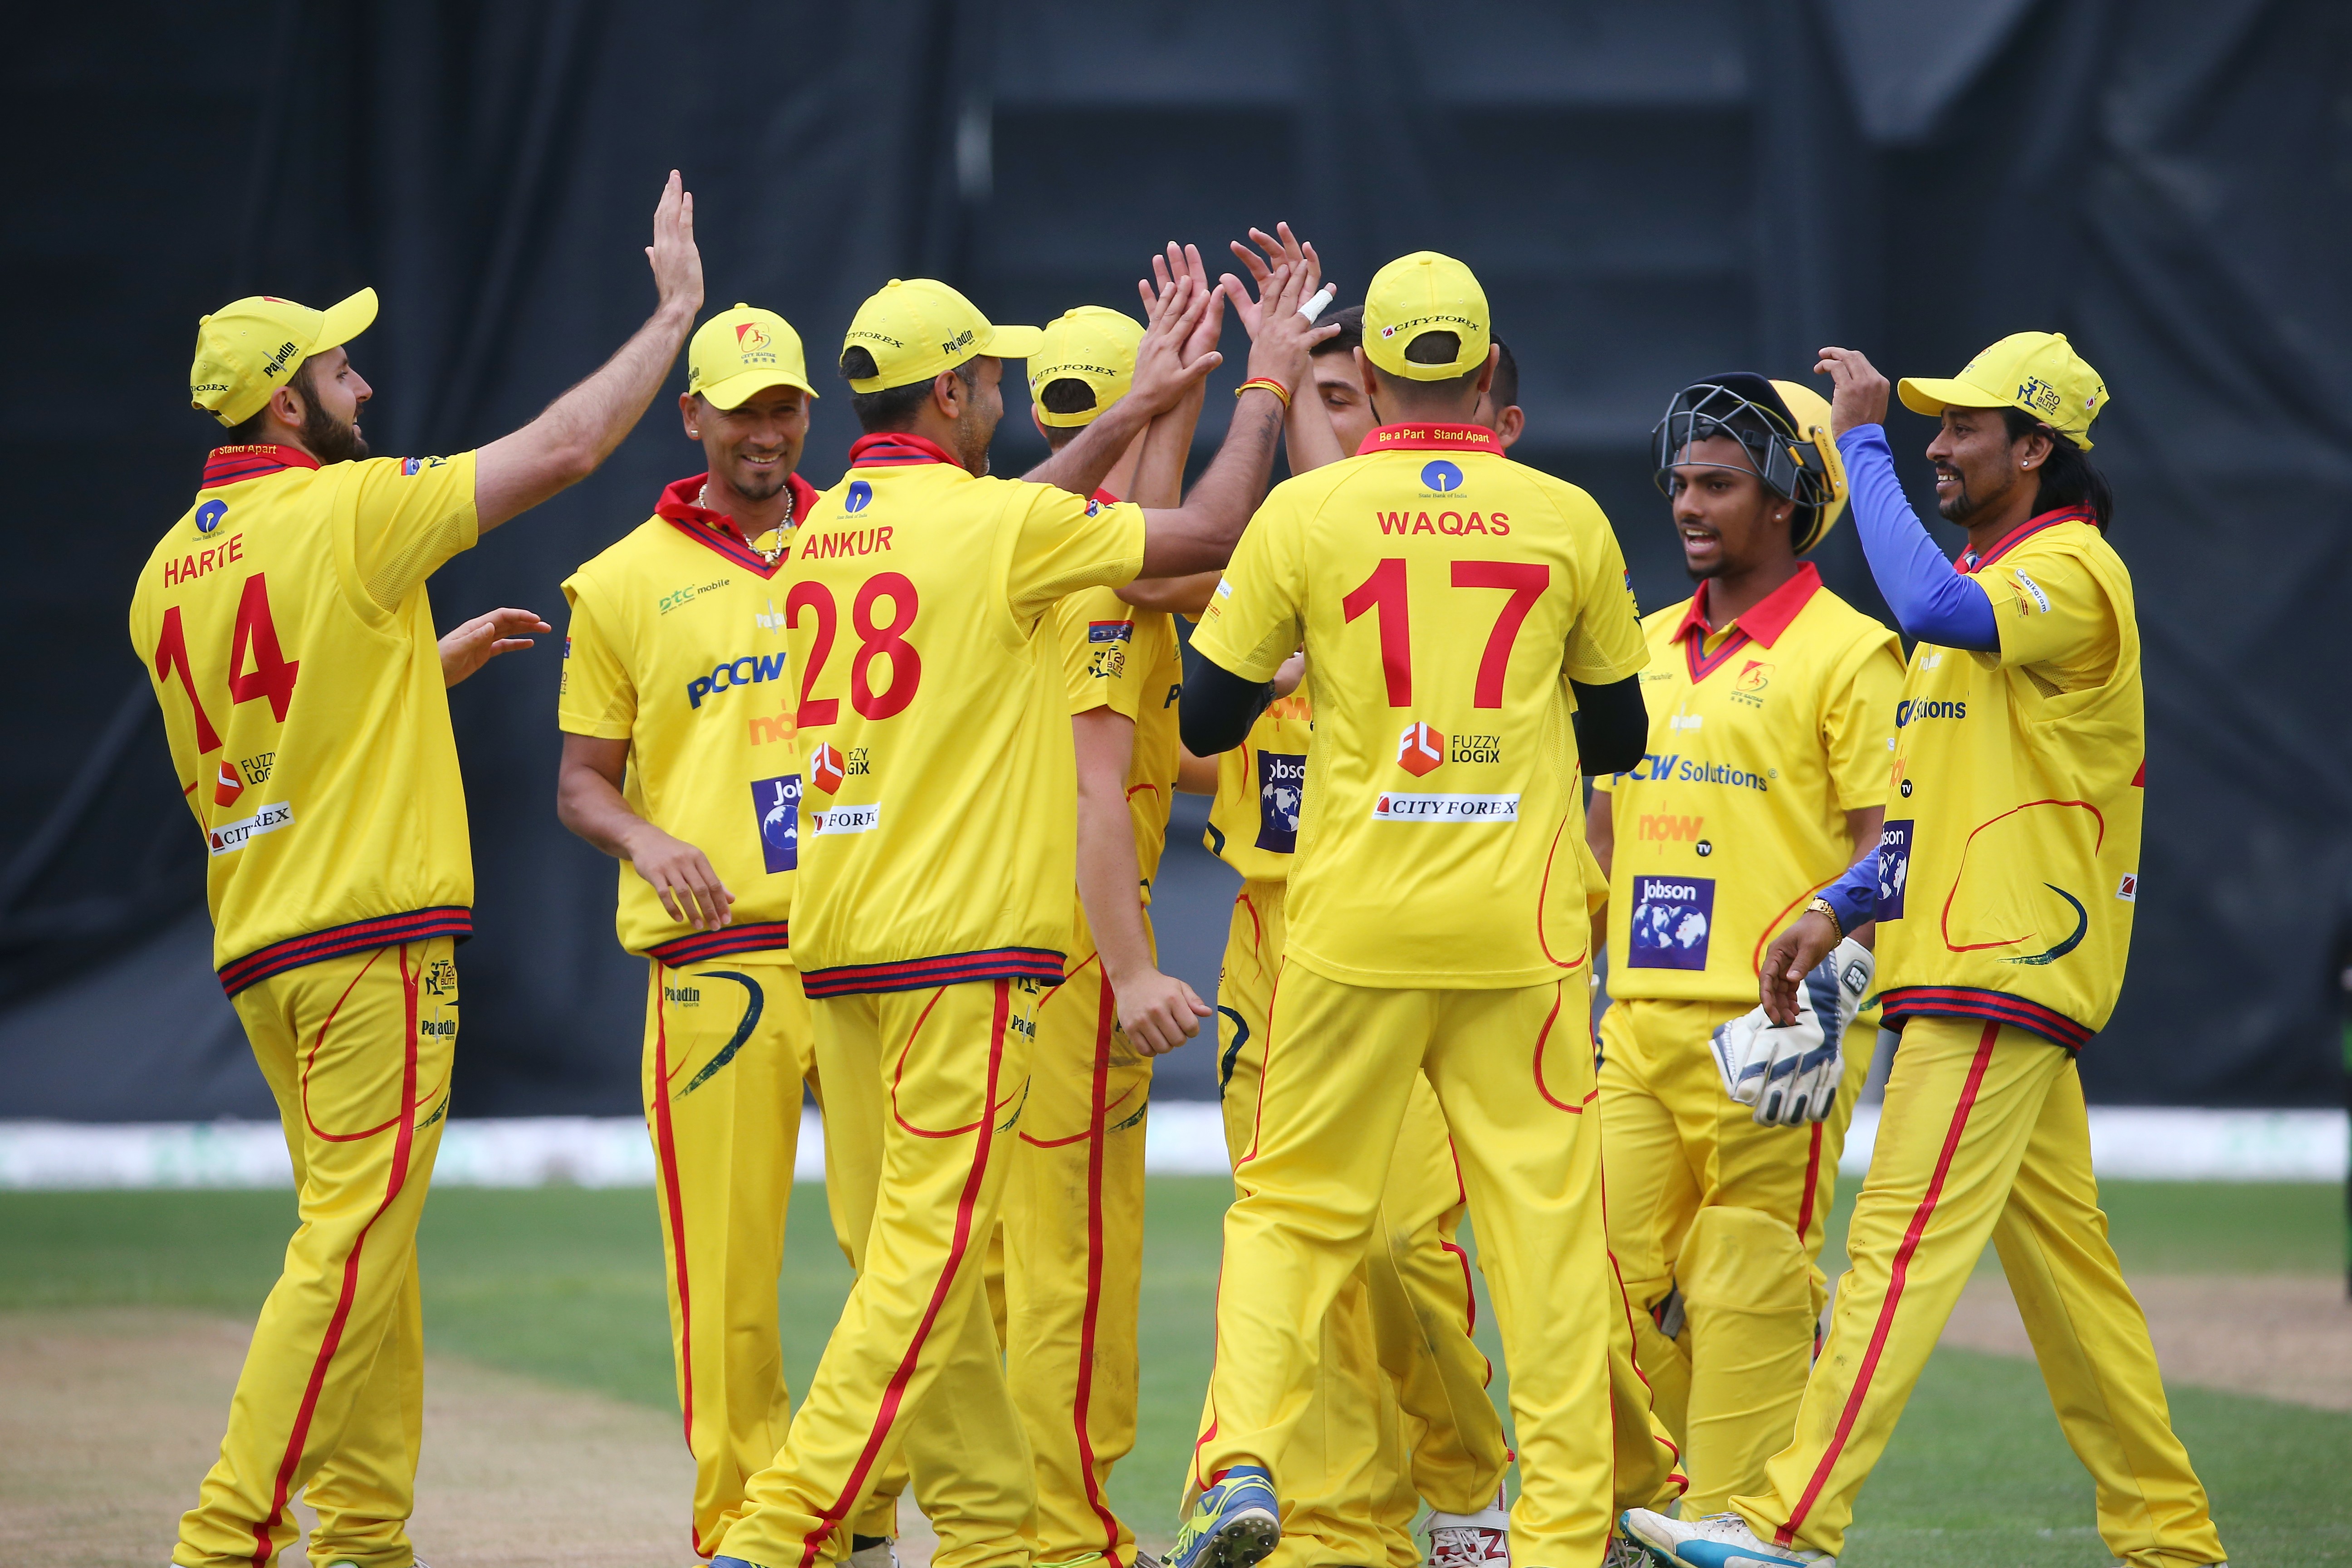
[1592,562,1903,1001]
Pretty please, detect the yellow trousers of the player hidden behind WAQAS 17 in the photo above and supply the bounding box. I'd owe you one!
[1195,882,1510,1568]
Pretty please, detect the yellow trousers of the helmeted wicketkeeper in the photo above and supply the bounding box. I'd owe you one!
[1602,999,1870,1519]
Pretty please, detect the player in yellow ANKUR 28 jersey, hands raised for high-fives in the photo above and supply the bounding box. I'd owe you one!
[717,261,1345,1568]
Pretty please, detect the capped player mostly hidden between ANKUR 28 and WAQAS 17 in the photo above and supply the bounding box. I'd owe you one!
[1004,306,1206,1568]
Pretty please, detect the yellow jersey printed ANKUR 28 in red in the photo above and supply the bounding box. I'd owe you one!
[783,435,1143,997]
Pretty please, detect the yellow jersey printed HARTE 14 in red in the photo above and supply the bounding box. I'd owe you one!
[129,446,477,997]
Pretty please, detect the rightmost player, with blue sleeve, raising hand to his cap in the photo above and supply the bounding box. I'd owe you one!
[1627,332,2223,1568]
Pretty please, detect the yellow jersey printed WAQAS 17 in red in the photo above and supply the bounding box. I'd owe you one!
[1192,426,1649,990]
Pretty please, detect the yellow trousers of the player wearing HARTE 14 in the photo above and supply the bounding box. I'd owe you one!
[172,936,459,1568]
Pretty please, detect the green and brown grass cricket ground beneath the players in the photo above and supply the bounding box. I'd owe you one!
[0,1178,2352,1568]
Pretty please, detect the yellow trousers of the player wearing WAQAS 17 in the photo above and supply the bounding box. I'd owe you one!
[1195,964,1646,1563]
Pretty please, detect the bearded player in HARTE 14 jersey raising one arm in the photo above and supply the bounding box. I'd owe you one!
[129,174,703,1568]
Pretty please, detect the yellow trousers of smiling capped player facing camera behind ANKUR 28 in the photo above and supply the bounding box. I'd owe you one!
[642,952,892,1556]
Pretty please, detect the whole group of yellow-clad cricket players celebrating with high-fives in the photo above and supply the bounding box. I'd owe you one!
[132,174,2223,1568]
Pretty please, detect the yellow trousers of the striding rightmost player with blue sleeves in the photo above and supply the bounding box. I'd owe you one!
[1734,1018,2223,1568]
